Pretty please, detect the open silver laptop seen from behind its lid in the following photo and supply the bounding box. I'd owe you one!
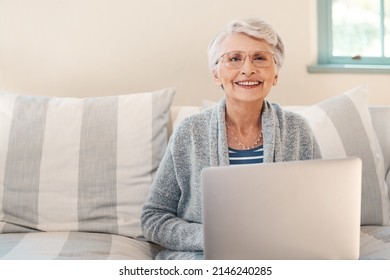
[201,158,362,260]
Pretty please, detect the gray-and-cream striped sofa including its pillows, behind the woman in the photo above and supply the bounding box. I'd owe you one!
[0,86,390,260]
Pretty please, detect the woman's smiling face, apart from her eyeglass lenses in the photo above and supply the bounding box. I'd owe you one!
[213,33,278,103]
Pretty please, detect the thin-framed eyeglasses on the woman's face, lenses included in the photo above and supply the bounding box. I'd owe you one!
[217,51,274,68]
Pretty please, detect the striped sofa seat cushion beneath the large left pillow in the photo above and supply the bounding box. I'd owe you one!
[0,232,160,260]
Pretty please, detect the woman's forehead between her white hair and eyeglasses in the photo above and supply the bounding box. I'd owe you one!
[220,33,272,53]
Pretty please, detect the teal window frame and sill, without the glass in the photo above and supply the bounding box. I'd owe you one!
[308,0,390,73]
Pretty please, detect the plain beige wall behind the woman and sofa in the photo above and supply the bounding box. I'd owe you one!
[0,0,390,105]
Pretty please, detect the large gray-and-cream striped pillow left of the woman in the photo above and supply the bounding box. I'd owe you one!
[0,89,174,238]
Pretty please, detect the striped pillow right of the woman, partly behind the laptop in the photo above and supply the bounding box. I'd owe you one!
[298,86,390,225]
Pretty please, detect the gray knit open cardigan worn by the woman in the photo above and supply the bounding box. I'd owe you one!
[141,98,321,259]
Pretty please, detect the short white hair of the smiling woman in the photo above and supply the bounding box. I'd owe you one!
[208,18,284,72]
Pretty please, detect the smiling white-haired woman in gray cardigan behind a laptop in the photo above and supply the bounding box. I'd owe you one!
[141,18,320,259]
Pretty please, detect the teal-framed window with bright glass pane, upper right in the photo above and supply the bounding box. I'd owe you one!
[309,0,390,72]
